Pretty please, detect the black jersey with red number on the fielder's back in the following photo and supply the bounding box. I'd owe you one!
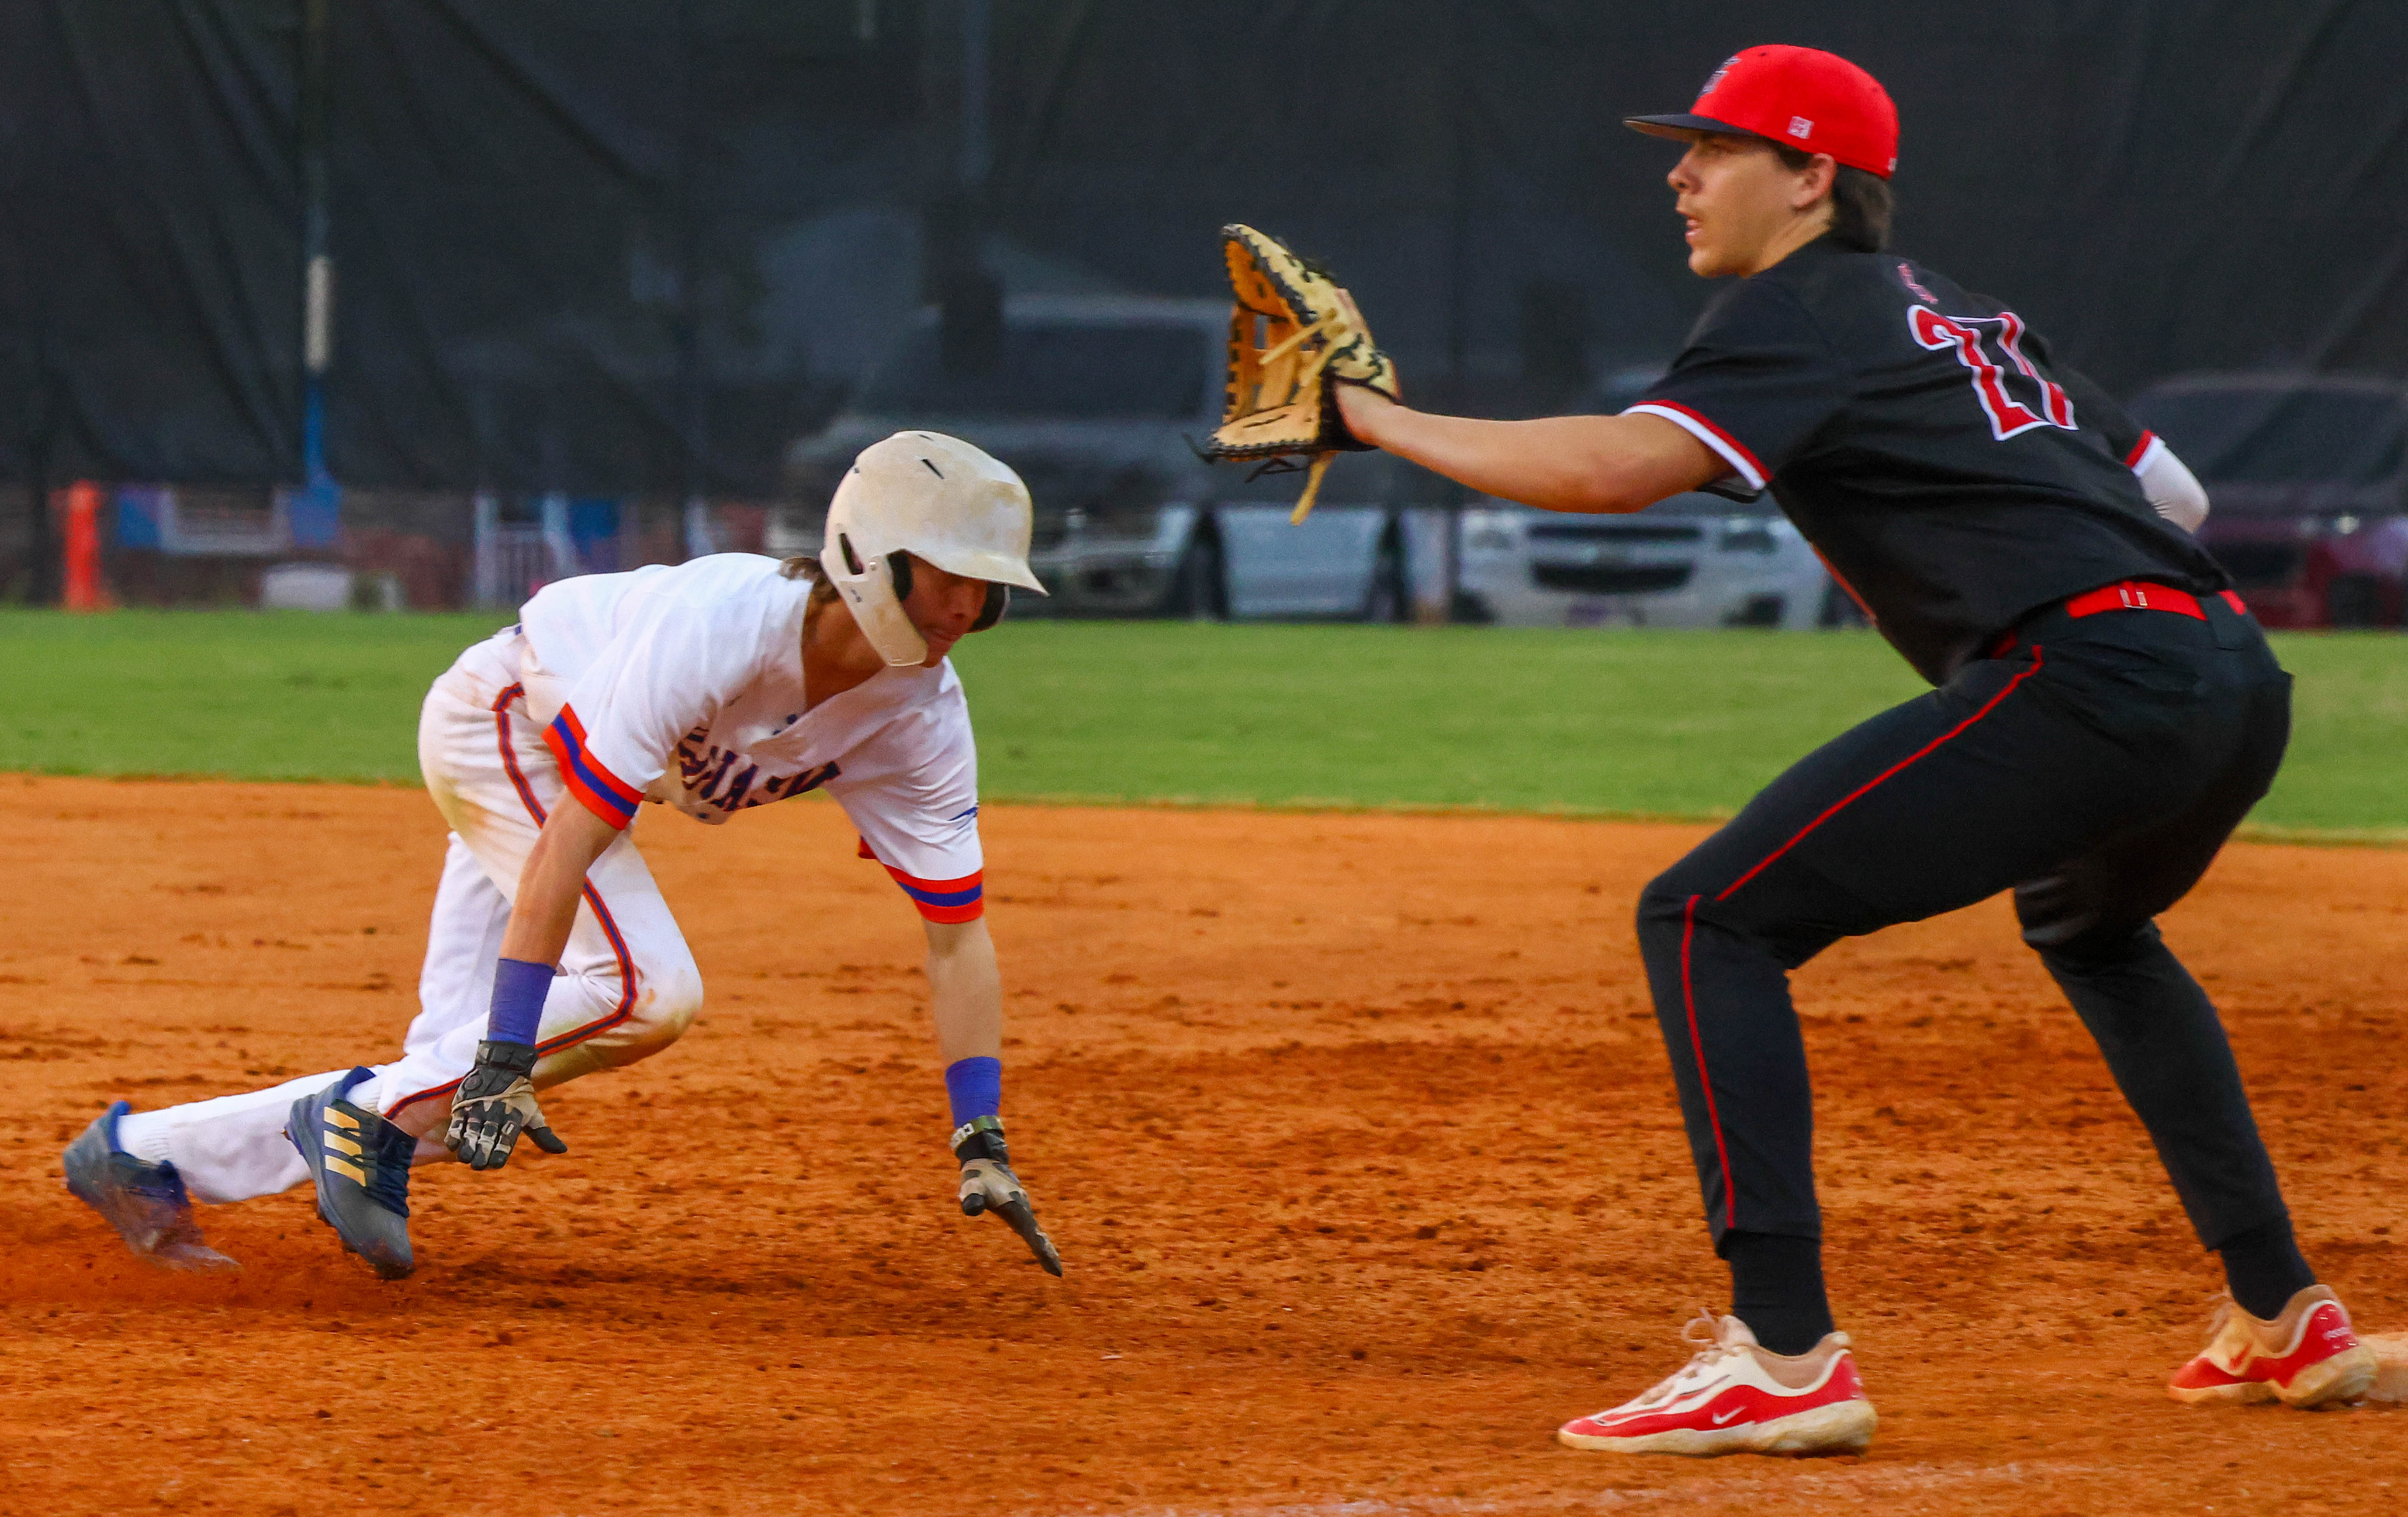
[1630,238,2227,684]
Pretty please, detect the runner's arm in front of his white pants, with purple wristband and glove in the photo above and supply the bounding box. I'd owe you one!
[443,802,619,1170]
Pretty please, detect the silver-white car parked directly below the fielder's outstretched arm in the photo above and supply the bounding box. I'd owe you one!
[1461,494,1857,629]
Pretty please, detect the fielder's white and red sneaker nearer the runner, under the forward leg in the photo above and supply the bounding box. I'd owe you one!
[1556,1313,1878,1457]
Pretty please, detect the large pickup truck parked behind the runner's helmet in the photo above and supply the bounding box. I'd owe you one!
[768,296,1440,621]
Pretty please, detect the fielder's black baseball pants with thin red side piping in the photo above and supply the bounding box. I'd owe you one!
[1637,600,2290,1250]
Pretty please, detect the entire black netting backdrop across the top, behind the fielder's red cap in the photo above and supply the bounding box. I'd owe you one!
[0,0,2408,498]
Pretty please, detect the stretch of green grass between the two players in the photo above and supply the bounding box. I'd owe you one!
[956,621,1917,816]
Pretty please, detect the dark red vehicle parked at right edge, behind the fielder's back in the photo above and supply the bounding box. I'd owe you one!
[2131,373,2408,626]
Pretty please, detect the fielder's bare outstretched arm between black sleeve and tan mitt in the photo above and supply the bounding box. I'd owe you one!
[1337,385,1731,513]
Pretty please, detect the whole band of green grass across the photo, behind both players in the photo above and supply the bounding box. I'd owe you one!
[0,612,2408,838]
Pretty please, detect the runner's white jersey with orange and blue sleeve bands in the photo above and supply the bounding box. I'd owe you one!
[520,554,985,922]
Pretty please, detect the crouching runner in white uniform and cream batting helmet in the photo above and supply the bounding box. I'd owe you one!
[65,431,1062,1279]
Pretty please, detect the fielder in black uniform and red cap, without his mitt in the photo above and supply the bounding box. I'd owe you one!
[1339,48,2374,1454]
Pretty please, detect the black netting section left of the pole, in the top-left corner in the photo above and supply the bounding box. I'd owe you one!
[0,0,301,479]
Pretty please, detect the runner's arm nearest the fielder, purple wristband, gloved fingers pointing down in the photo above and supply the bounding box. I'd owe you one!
[922,917,1062,1274]
